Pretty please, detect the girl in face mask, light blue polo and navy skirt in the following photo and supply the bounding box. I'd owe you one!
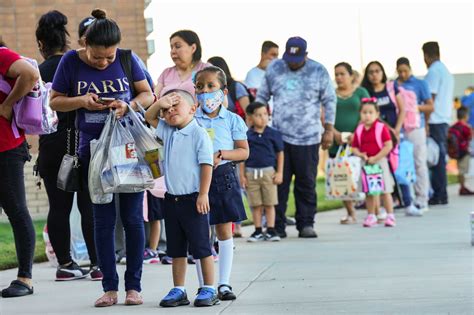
[195,66,249,301]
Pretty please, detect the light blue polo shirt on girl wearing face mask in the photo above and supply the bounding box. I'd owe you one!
[194,106,248,159]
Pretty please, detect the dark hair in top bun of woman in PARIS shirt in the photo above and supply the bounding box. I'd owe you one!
[84,9,122,47]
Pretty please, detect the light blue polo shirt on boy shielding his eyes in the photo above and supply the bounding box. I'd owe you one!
[155,119,214,195]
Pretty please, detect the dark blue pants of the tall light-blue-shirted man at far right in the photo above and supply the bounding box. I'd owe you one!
[430,124,449,201]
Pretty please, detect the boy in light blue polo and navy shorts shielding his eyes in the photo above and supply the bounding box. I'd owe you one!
[145,90,219,307]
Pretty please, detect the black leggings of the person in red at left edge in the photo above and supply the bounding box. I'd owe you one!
[0,142,35,279]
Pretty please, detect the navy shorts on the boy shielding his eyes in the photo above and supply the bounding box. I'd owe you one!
[164,193,212,259]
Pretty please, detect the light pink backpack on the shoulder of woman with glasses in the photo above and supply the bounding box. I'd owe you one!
[387,81,421,131]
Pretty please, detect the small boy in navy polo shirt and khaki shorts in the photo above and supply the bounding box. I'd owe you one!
[240,102,284,242]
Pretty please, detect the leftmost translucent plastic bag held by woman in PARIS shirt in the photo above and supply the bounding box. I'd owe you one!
[88,112,115,204]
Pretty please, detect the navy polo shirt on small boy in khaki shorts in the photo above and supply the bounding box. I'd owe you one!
[245,126,283,168]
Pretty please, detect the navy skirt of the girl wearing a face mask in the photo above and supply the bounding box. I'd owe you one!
[209,163,247,225]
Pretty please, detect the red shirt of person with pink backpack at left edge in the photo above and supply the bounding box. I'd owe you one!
[0,47,25,152]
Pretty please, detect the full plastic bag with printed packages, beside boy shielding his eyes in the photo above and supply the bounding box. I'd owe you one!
[101,114,154,193]
